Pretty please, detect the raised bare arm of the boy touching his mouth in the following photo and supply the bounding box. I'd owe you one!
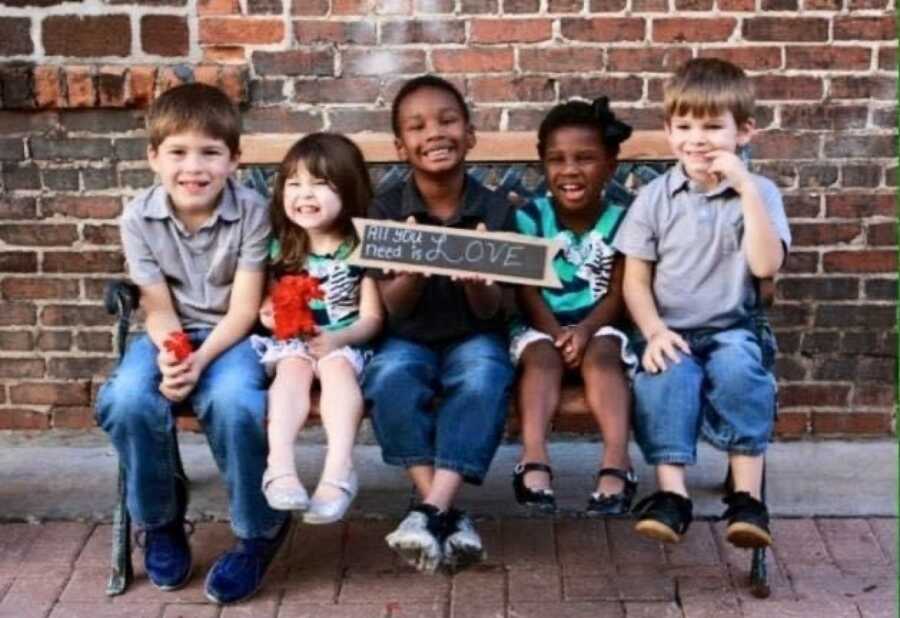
[709,150,784,277]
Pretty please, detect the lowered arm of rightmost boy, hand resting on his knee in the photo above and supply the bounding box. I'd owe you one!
[622,256,691,373]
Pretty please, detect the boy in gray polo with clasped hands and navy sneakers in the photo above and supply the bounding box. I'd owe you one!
[97,84,289,603]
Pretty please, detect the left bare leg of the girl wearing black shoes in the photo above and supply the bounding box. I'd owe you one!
[517,341,563,489]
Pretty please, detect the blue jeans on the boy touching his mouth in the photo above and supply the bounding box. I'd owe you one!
[634,324,776,465]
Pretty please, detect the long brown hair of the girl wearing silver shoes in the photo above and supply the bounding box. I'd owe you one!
[270,133,373,275]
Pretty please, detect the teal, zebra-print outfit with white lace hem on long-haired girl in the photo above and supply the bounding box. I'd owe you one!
[250,240,371,376]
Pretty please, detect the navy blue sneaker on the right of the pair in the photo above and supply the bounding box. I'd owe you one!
[206,517,291,605]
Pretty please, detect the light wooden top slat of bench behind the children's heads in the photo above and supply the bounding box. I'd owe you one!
[241,131,672,165]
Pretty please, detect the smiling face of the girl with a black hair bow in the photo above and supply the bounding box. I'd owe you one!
[543,126,616,214]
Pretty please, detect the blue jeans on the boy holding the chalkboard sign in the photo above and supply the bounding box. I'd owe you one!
[363,334,513,485]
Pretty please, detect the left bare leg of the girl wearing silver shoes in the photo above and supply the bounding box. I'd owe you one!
[266,358,313,489]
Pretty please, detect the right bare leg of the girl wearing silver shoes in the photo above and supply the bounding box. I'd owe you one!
[314,357,363,501]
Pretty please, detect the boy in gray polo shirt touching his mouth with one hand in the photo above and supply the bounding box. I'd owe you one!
[614,59,791,547]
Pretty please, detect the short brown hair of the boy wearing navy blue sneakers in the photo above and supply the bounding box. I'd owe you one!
[147,82,241,156]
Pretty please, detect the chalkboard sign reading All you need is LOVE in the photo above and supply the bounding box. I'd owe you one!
[350,219,562,288]
